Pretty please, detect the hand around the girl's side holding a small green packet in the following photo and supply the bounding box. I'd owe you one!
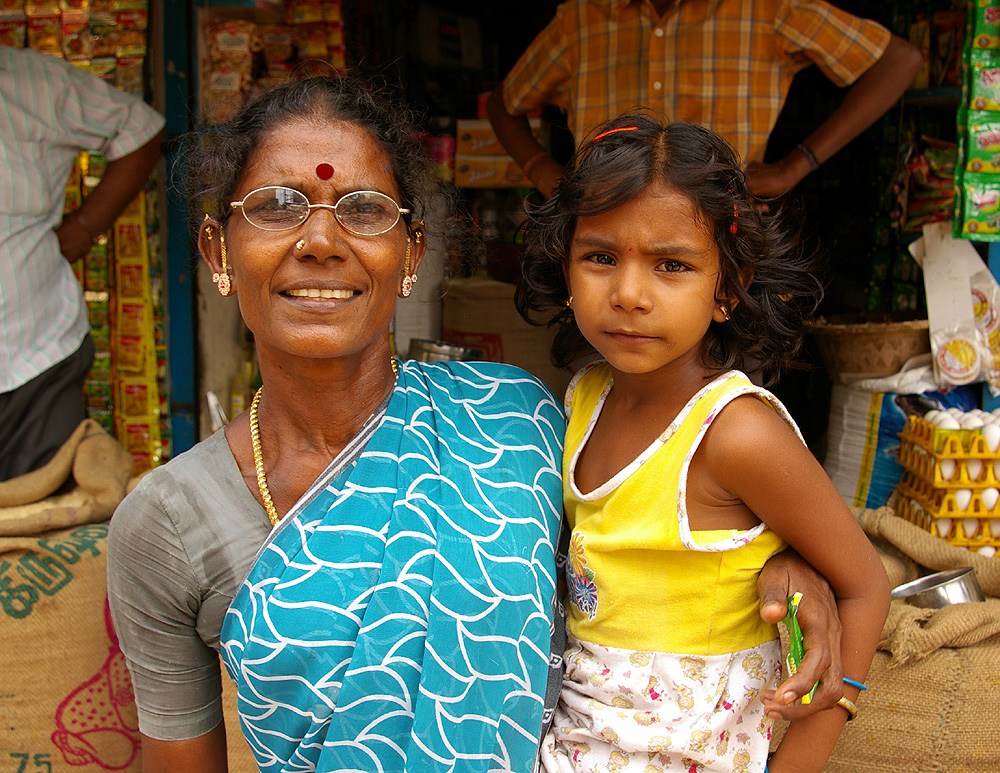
[757,548,844,720]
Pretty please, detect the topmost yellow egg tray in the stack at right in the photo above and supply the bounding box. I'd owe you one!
[898,416,1000,482]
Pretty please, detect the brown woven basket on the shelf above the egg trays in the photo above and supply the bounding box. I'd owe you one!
[809,317,931,384]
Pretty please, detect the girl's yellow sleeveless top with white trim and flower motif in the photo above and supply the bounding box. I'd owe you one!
[563,363,801,655]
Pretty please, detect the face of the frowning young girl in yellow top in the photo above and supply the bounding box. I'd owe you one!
[566,182,725,374]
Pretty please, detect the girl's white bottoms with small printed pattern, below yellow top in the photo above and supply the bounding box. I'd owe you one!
[542,635,781,773]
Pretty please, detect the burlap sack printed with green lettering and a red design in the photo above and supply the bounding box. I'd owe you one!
[0,523,141,773]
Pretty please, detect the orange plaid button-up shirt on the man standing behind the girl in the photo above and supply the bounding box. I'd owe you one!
[503,0,890,161]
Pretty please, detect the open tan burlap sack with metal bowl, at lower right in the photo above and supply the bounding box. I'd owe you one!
[772,507,1000,773]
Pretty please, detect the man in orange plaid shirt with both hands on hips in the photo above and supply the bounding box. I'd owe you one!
[487,0,921,196]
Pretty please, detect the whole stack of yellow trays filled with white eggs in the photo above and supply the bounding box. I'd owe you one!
[896,408,1000,556]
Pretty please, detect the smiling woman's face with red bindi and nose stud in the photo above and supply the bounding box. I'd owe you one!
[201,118,424,358]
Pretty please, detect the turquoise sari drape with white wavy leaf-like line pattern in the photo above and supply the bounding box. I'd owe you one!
[222,362,564,773]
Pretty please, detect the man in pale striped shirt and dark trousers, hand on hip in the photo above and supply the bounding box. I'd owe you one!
[0,46,164,480]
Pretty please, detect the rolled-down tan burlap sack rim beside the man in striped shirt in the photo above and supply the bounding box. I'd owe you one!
[0,419,132,536]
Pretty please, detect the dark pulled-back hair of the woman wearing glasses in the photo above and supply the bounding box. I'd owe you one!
[183,74,436,235]
